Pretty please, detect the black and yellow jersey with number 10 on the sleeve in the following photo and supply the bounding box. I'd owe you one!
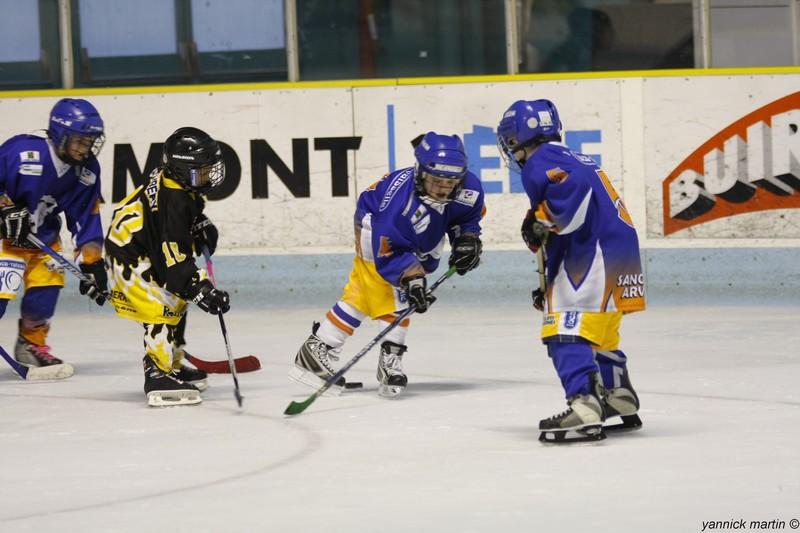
[105,168,205,297]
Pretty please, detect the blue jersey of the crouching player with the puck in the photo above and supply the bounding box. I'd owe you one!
[355,167,485,286]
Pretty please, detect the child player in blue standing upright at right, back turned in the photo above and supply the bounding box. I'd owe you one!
[497,100,645,442]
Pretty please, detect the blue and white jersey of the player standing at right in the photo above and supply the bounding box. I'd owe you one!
[522,142,645,312]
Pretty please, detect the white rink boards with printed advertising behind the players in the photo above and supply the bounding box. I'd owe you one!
[0,69,800,253]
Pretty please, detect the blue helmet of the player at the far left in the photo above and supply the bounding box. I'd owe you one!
[47,98,105,165]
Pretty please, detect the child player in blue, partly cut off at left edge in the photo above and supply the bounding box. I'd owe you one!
[0,98,108,380]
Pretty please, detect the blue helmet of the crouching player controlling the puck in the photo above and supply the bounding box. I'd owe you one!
[414,131,467,204]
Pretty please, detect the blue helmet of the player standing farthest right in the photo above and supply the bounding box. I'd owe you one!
[497,100,561,170]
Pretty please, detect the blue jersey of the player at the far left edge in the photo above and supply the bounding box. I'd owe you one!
[0,135,103,248]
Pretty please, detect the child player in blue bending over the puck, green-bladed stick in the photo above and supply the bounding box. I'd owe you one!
[289,132,484,397]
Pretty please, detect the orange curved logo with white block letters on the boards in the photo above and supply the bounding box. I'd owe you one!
[662,92,800,235]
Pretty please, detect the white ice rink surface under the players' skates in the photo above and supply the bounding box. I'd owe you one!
[0,302,800,533]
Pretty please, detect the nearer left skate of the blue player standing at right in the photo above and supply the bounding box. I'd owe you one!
[539,394,606,443]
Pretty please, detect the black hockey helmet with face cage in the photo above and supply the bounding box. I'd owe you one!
[164,127,225,190]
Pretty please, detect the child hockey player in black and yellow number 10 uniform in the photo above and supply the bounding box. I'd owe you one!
[106,128,230,407]
